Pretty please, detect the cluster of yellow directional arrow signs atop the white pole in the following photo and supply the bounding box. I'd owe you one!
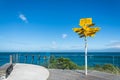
[73,18,100,37]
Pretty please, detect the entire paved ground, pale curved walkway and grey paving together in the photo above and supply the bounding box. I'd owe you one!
[3,63,120,80]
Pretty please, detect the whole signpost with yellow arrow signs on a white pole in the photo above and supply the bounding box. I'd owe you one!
[73,18,100,75]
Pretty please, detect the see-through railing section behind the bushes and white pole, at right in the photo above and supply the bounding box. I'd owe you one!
[52,55,120,67]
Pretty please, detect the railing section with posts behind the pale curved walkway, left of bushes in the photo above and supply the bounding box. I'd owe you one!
[12,54,50,67]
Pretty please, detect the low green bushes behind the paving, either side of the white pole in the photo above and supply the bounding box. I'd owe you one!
[49,56,120,74]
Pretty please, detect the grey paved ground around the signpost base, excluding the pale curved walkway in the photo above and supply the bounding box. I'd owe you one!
[48,69,120,80]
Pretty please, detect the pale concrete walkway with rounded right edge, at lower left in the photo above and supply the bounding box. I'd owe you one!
[6,63,49,80]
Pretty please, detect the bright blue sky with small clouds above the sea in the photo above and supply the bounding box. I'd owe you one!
[0,0,120,51]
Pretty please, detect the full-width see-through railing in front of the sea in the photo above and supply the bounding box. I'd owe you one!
[0,54,120,67]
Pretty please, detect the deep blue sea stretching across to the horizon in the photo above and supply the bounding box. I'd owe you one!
[0,52,120,67]
